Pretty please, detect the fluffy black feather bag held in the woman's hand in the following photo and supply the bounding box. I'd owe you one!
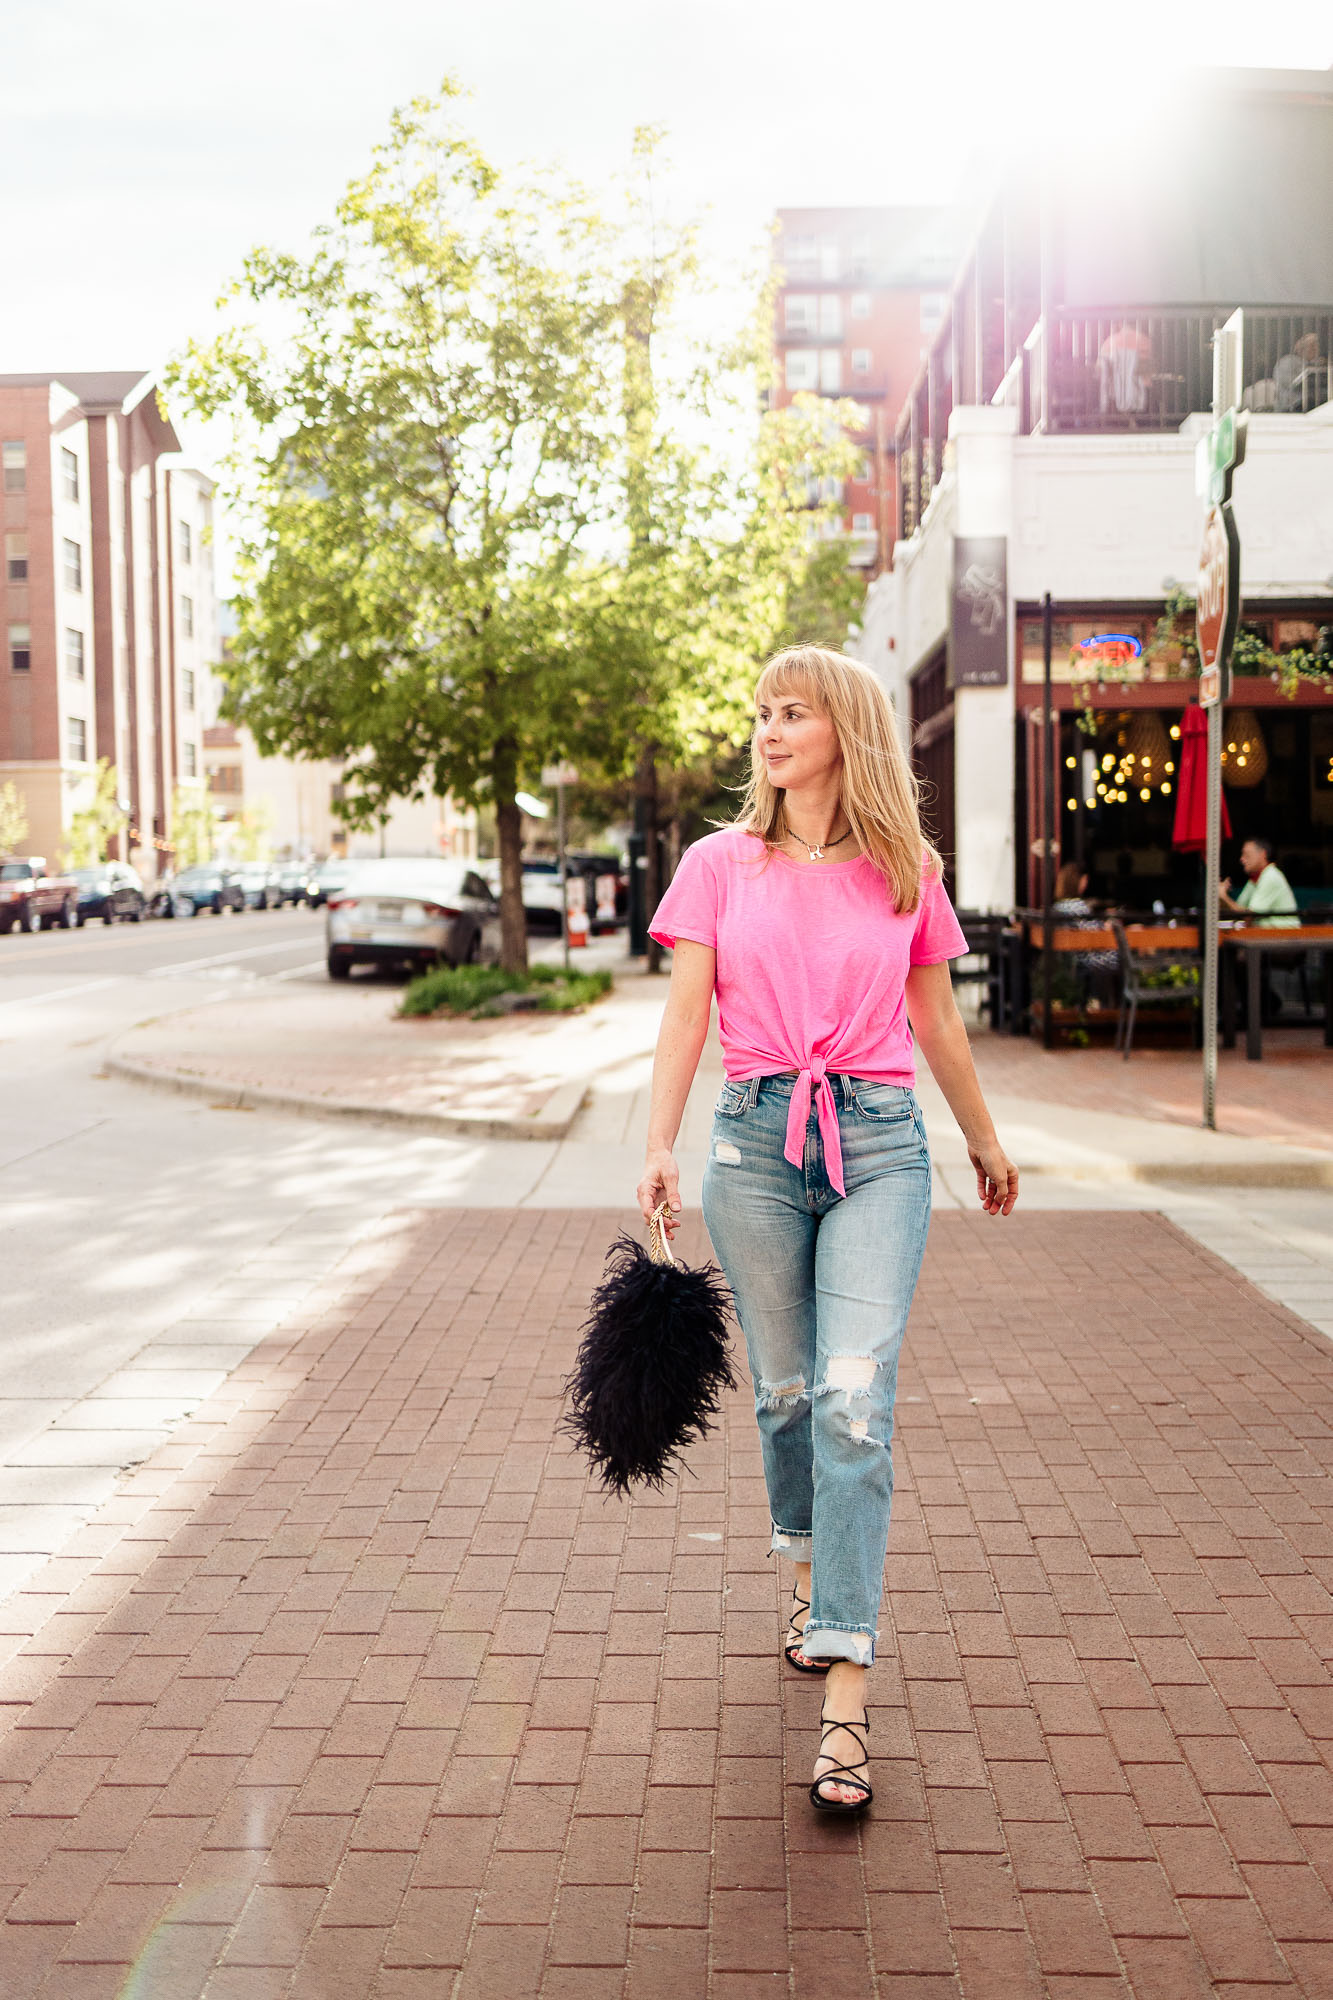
[558,1202,737,1494]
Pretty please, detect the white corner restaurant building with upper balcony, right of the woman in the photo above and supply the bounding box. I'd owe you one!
[849,70,1333,910]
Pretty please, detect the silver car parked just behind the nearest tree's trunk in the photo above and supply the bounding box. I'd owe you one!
[324,860,500,980]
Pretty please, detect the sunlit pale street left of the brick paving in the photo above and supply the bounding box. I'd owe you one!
[0,910,588,1594]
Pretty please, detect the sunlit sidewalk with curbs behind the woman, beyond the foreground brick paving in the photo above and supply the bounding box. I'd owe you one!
[108,940,1333,1200]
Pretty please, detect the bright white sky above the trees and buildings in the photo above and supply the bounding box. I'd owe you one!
[0,0,1333,496]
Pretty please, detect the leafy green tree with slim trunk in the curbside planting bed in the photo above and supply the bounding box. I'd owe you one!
[172,84,632,968]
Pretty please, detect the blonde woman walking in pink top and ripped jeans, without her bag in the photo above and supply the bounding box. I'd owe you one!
[638,646,1019,1812]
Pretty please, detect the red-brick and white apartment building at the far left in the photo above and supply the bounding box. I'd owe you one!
[0,372,218,876]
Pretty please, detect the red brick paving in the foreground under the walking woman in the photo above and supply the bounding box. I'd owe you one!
[0,1210,1333,2000]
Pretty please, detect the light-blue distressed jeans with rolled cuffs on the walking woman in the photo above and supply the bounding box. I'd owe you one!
[703,1076,931,1666]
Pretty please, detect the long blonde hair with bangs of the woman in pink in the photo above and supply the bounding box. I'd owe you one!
[731,646,943,912]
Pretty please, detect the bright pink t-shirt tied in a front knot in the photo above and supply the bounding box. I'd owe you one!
[650,826,967,1194]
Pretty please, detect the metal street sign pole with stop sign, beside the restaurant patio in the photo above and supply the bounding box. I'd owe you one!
[1197,310,1245,1132]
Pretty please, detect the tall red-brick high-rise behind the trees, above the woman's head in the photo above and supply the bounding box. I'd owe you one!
[773,206,961,574]
